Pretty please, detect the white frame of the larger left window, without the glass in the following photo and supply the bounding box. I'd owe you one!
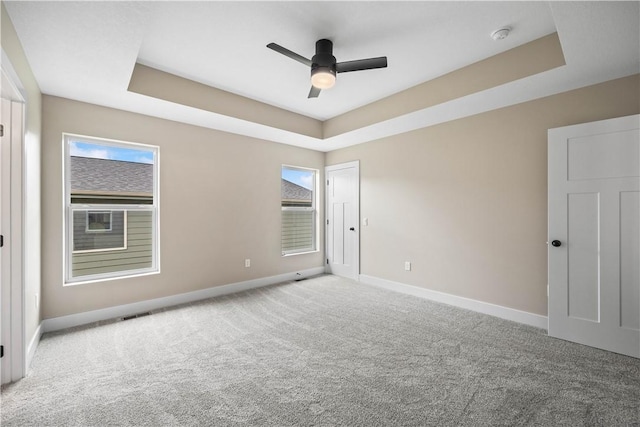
[62,132,160,286]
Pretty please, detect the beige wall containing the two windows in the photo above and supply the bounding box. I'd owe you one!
[42,96,324,318]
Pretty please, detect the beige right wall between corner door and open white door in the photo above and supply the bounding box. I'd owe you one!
[326,75,640,315]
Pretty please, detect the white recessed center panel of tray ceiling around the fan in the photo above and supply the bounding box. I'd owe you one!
[138,2,555,120]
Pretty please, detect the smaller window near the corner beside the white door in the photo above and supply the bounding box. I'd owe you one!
[281,166,318,256]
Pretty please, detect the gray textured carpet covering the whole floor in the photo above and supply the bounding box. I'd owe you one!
[1,276,640,427]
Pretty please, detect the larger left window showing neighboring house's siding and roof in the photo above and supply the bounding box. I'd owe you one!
[64,135,159,284]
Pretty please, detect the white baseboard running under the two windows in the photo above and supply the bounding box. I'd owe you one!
[42,267,325,332]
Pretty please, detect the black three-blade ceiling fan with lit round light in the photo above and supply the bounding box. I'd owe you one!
[267,39,387,98]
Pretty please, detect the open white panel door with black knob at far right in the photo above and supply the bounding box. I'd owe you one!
[548,116,640,357]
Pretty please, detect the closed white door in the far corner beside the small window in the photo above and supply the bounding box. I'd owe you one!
[325,161,360,280]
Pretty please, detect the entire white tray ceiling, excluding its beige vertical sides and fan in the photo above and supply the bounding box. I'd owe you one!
[4,1,640,151]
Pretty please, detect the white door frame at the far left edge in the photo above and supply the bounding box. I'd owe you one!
[0,57,27,383]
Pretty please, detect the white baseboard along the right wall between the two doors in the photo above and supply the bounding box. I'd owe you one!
[360,274,548,330]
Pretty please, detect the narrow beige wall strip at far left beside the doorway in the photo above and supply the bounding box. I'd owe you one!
[0,3,42,345]
